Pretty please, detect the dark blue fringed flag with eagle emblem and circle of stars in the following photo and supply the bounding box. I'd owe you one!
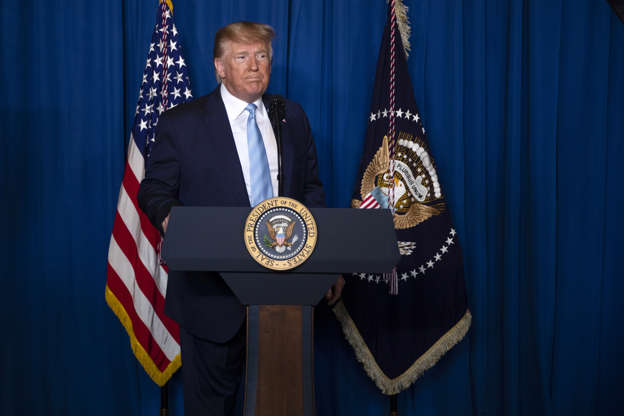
[334,1,472,395]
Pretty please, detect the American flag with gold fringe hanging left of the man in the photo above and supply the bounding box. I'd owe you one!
[105,0,192,386]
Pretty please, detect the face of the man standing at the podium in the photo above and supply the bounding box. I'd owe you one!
[214,41,271,103]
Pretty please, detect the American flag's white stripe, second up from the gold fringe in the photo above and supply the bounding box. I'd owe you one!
[117,186,167,297]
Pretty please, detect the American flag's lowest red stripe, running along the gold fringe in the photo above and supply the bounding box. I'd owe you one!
[106,264,171,371]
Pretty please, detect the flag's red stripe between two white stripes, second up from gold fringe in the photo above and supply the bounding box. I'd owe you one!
[113,213,180,344]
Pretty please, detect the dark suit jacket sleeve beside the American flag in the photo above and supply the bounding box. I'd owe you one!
[138,113,182,234]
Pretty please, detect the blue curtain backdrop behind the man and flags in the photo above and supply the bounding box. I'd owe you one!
[0,0,624,416]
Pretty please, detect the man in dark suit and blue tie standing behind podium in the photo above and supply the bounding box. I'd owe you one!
[139,22,344,415]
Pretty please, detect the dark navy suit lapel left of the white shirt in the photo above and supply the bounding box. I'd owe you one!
[204,86,250,206]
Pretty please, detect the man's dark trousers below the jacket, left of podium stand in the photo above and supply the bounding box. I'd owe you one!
[180,325,245,416]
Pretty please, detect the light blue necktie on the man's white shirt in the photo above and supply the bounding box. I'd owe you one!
[245,104,273,207]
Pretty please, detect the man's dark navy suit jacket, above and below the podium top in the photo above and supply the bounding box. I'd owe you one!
[138,87,324,342]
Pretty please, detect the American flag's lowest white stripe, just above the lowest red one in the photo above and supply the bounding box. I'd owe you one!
[108,236,180,361]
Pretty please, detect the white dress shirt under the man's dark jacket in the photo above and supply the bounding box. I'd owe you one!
[221,84,278,200]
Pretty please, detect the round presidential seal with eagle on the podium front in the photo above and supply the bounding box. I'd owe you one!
[244,197,317,270]
